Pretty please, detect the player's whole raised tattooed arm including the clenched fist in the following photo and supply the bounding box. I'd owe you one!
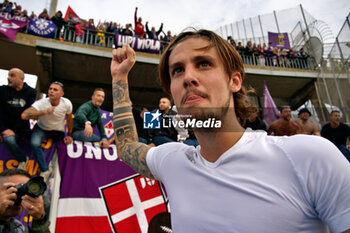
[111,45,153,178]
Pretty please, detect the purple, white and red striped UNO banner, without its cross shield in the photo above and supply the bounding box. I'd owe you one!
[55,141,136,233]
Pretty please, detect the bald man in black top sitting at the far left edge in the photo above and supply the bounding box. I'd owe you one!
[0,68,36,169]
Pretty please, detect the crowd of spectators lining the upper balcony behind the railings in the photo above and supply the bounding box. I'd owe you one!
[0,0,314,69]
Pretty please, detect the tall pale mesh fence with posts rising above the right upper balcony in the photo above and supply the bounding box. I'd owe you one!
[216,5,334,68]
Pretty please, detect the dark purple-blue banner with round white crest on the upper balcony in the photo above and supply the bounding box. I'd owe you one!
[28,19,56,38]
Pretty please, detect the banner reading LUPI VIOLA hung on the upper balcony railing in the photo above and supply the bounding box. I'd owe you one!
[115,34,162,53]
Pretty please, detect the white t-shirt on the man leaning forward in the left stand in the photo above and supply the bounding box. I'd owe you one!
[32,97,73,132]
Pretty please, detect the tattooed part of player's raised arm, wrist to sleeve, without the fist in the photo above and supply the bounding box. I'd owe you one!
[113,81,153,177]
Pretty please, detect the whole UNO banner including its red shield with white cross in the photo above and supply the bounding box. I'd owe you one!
[55,141,166,233]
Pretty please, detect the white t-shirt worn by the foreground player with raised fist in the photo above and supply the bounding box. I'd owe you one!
[146,129,350,233]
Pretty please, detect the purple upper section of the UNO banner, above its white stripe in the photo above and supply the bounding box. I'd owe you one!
[57,141,136,198]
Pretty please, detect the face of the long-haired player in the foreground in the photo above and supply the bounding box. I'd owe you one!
[169,38,241,119]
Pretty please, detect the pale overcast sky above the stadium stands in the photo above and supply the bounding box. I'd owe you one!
[12,0,350,37]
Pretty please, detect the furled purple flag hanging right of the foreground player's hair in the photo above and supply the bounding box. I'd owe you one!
[263,80,280,126]
